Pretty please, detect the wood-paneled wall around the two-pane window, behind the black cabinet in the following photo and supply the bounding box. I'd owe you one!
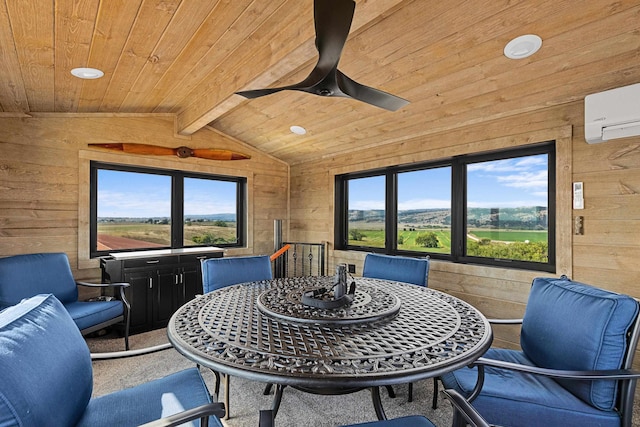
[0,114,289,288]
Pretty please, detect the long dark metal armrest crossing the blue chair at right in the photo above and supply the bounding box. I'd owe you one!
[473,357,640,381]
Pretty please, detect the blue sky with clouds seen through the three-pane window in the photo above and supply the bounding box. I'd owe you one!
[349,155,547,210]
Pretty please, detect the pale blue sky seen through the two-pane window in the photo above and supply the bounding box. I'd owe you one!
[98,170,236,218]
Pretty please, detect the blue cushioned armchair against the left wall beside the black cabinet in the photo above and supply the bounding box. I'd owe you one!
[0,253,130,350]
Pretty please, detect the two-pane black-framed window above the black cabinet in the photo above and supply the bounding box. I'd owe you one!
[90,162,246,257]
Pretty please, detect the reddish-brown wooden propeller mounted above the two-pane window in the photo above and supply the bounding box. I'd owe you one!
[89,142,251,160]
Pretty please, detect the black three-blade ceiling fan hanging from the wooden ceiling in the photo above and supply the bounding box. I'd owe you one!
[236,0,409,111]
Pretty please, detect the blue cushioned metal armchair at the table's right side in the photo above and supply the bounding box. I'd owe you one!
[441,276,640,427]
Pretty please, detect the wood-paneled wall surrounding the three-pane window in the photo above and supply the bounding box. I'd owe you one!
[290,102,640,360]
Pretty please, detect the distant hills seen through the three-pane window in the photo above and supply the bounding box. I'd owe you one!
[349,206,548,230]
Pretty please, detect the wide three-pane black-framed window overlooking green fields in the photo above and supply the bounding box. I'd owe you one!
[335,142,555,272]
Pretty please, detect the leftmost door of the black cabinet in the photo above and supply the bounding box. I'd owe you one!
[124,270,153,333]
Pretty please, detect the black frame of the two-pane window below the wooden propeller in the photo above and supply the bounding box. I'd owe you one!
[89,160,247,258]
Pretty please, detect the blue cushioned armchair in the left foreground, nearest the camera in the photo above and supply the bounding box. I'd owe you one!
[0,294,224,427]
